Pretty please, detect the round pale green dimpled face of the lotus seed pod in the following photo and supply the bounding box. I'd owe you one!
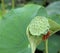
[28,16,50,36]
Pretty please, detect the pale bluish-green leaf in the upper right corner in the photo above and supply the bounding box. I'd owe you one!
[46,1,60,15]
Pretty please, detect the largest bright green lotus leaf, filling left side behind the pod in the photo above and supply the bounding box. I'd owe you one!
[0,4,47,53]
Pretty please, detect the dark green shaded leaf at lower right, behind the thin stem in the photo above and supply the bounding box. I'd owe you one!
[37,34,60,53]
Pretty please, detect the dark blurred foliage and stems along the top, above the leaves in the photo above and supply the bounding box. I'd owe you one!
[0,0,59,10]
